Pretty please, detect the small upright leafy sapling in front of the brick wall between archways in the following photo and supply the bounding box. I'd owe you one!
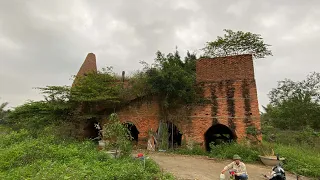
[103,113,132,156]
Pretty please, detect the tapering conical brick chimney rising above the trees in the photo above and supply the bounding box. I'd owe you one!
[72,53,97,86]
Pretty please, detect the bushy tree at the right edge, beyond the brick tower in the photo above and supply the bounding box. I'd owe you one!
[263,72,320,130]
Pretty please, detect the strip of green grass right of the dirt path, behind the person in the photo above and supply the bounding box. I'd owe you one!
[172,139,320,178]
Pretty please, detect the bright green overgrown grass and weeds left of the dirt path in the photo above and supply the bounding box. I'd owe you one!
[0,127,173,180]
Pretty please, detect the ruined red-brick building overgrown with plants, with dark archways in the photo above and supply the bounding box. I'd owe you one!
[77,53,261,149]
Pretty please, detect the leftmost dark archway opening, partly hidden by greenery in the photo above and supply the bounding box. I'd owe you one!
[83,118,101,141]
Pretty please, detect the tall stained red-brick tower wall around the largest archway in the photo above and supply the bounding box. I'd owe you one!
[192,55,261,142]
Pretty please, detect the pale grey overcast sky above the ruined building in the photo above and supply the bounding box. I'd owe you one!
[0,0,320,110]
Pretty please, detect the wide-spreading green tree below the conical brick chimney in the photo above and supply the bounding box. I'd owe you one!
[8,68,123,136]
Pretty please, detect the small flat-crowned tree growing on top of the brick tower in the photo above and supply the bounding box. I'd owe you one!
[202,29,272,59]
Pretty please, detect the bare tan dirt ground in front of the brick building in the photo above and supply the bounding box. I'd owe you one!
[140,152,309,180]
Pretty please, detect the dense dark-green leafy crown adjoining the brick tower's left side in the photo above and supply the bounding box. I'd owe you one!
[140,51,196,109]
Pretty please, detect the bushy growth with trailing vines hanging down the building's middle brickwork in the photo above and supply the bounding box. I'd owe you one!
[130,51,198,148]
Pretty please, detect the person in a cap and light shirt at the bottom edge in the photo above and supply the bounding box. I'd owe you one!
[221,154,248,180]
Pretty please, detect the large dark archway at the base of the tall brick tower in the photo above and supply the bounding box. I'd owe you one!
[204,124,236,151]
